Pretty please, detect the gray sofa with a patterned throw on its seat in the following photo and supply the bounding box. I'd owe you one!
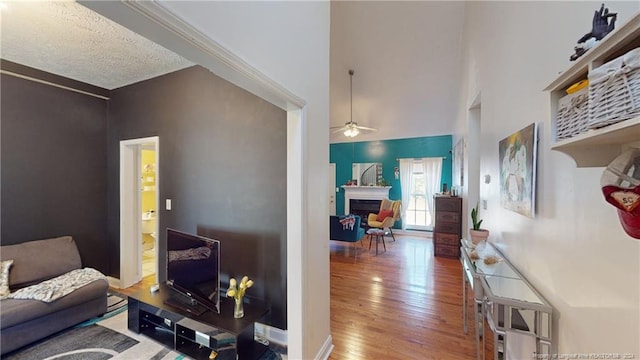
[0,236,109,354]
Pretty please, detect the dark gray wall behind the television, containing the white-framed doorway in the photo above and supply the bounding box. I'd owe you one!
[108,66,287,329]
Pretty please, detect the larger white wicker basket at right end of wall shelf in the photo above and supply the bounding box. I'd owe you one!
[588,48,640,129]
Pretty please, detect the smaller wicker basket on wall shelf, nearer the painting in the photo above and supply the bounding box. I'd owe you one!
[556,88,589,140]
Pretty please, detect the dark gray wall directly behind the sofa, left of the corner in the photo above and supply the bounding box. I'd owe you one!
[0,74,109,273]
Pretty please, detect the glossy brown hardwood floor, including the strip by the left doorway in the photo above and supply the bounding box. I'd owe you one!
[114,235,484,360]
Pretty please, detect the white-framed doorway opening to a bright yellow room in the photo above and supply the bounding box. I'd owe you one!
[120,136,160,288]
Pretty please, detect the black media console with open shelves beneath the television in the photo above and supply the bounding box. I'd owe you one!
[128,284,267,360]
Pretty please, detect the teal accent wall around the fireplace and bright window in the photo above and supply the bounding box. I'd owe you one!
[329,135,453,215]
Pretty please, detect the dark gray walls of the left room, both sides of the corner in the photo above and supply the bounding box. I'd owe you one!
[0,61,287,329]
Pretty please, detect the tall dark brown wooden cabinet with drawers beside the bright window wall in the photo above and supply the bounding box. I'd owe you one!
[433,196,462,257]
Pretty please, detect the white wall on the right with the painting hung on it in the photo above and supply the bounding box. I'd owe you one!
[457,1,640,358]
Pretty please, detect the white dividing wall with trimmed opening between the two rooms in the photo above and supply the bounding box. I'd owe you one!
[84,1,332,359]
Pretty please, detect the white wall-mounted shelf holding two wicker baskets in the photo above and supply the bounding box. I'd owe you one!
[545,12,640,167]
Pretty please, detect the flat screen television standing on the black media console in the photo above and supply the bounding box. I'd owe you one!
[167,228,220,315]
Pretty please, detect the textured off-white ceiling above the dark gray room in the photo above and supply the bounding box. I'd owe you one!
[0,1,194,90]
